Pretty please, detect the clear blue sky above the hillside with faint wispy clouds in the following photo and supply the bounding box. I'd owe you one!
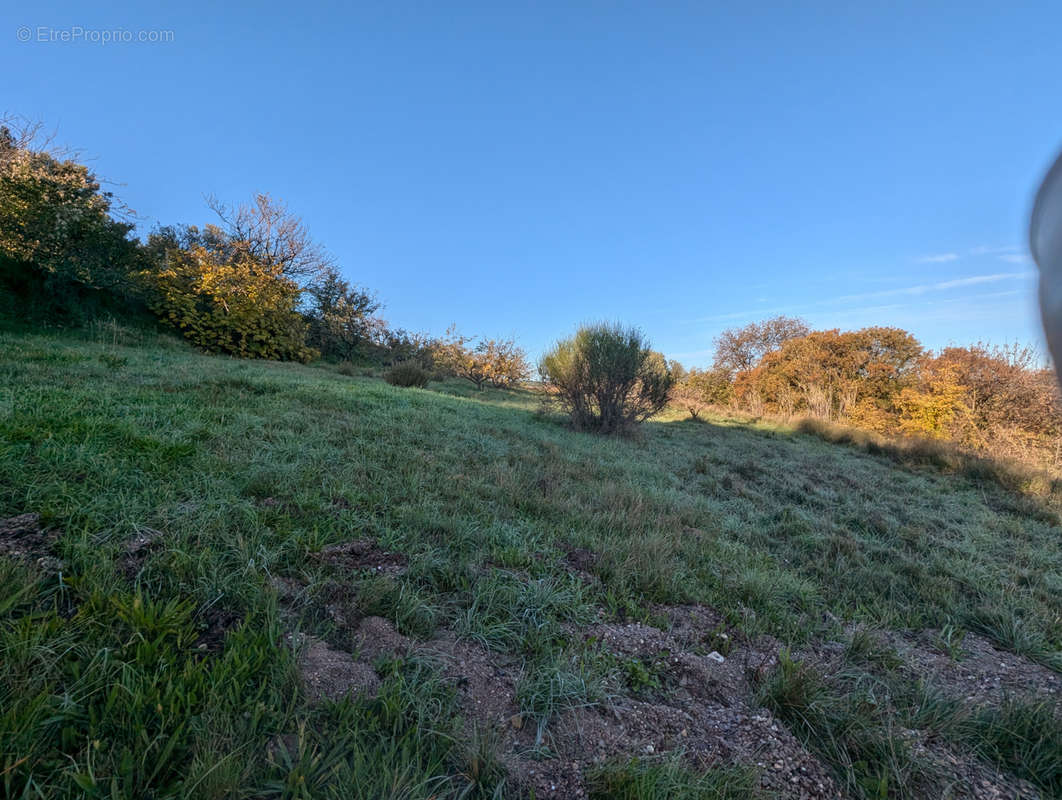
[0,0,1062,364]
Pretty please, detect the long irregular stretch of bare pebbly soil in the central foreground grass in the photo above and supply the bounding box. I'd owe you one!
[290,606,839,798]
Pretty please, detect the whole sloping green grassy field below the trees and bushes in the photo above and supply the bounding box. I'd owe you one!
[0,329,1062,798]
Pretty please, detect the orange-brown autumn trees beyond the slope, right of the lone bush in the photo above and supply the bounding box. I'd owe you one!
[673,317,1062,465]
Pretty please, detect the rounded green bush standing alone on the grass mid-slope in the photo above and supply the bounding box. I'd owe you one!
[538,323,673,433]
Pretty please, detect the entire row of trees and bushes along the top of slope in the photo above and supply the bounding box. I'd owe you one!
[0,120,1062,465]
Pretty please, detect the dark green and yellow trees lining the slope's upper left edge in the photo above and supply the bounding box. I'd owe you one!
[0,119,529,387]
